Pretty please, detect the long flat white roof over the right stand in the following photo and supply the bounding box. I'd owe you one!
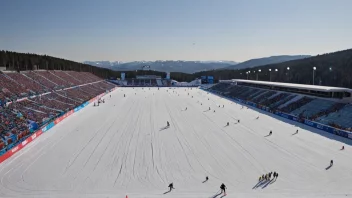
[231,79,352,93]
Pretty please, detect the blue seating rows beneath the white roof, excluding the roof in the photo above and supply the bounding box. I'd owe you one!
[209,83,352,131]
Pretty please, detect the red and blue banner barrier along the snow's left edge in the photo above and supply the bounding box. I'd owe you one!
[0,87,117,163]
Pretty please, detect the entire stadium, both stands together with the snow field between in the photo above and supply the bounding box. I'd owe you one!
[0,70,352,198]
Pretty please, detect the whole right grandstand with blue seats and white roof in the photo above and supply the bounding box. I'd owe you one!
[209,79,352,131]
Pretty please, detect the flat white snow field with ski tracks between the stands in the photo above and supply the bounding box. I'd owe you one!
[0,88,352,198]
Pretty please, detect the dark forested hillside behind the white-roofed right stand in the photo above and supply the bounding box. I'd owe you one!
[196,49,352,88]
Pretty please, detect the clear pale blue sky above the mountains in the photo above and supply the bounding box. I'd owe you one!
[0,0,352,61]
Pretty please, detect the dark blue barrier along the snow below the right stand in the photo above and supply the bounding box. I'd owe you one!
[202,89,352,139]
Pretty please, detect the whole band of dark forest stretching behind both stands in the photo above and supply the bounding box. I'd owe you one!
[0,49,352,88]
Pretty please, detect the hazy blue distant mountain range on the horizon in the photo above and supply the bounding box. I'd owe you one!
[83,55,310,73]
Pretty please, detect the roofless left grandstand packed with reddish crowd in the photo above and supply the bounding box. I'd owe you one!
[0,70,115,155]
